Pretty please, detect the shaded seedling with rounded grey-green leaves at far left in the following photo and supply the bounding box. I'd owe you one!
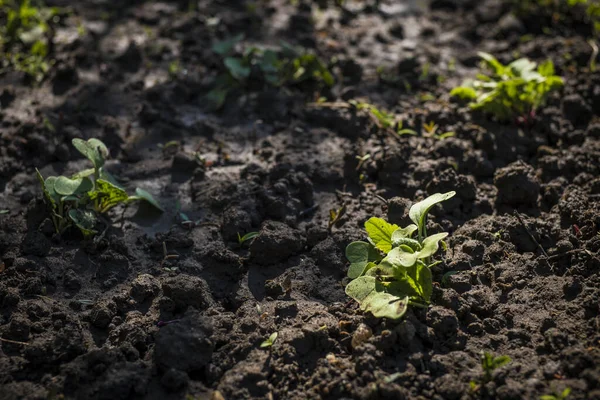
[36,139,162,238]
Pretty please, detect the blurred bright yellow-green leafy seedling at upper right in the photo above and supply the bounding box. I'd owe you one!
[450,53,563,121]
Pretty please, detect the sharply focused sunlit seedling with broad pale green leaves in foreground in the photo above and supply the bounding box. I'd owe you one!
[346,192,456,319]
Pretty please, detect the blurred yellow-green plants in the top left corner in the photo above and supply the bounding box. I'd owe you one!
[0,0,61,82]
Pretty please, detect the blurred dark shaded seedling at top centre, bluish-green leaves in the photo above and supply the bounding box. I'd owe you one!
[208,34,334,108]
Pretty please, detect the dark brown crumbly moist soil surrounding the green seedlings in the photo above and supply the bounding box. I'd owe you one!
[0,0,600,400]
